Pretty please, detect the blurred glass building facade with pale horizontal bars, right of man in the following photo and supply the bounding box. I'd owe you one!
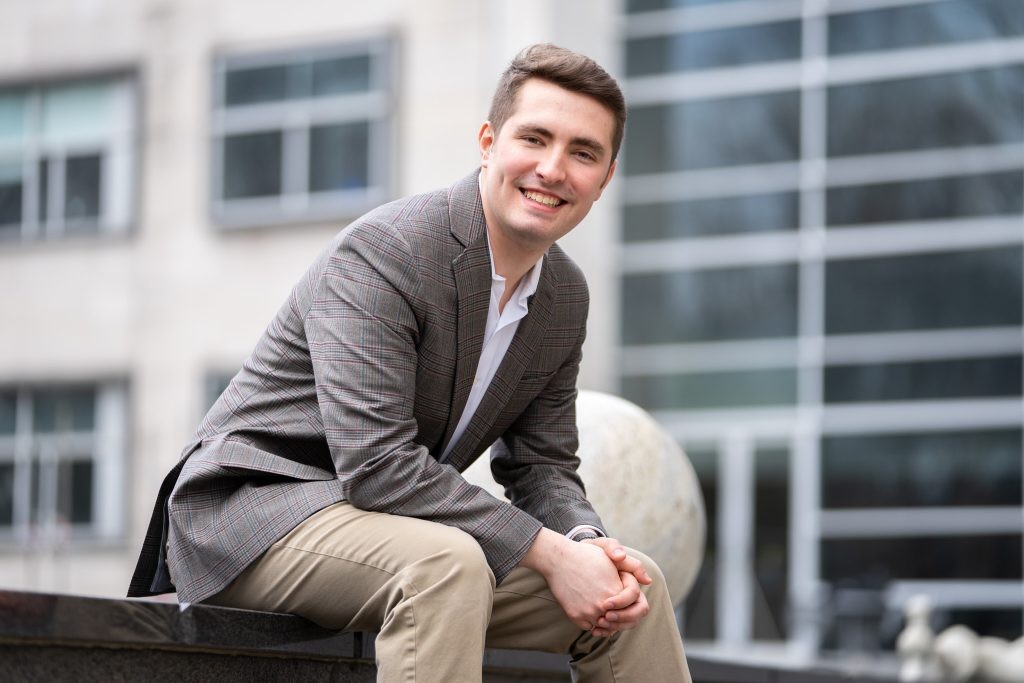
[621,0,1024,654]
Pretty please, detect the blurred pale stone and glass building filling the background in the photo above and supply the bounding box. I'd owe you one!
[0,0,1024,667]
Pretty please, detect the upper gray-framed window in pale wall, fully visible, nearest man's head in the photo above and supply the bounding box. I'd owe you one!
[213,40,391,225]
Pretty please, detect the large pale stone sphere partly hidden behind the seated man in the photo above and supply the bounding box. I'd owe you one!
[464,391,706,605]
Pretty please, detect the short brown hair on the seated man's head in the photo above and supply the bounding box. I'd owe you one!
[487,43,626,160]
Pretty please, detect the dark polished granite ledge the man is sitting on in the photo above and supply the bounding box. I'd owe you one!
[0,590,894,683]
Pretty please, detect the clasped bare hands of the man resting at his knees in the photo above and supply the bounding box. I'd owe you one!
[523,529,651,638]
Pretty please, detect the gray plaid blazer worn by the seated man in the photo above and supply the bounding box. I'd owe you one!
[128,172,601,602]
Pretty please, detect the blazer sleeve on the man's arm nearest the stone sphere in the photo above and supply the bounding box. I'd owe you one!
[490,325,604,533]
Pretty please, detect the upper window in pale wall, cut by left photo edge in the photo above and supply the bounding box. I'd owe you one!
[0,78,135,241]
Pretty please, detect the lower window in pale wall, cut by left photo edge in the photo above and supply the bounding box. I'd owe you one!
[0,385,125,543]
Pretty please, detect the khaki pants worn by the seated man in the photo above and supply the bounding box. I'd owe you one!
[207,503,690,683]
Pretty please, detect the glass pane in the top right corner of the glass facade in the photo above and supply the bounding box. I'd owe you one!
[828,0,1024,54]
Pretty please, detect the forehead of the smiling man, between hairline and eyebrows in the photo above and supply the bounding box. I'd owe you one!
[503,78,615,148]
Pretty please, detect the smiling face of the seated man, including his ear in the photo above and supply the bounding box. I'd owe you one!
[479,79,615,252]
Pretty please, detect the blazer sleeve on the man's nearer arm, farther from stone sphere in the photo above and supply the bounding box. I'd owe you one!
[304,224,542,582]
